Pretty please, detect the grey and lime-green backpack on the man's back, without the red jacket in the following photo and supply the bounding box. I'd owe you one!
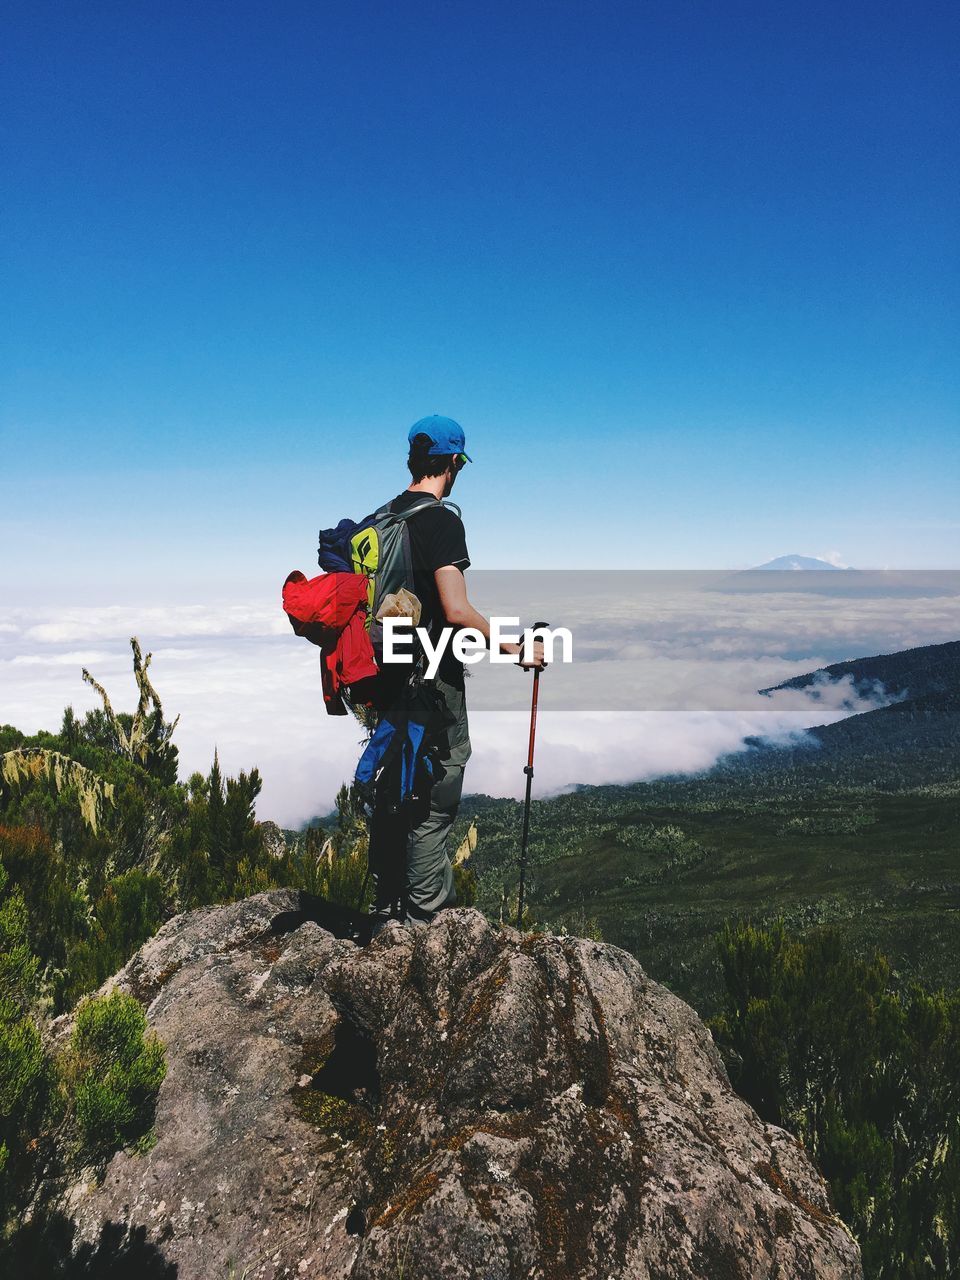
[317,498,460,667]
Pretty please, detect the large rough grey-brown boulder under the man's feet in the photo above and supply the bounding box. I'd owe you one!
[65,891,861,1280]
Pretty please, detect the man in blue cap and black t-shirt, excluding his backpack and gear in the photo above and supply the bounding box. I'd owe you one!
[370,415,543,932]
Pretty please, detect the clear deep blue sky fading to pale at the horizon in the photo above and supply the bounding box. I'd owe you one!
[0,0,960,603]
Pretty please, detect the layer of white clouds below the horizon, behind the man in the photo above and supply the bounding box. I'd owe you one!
[0,571,960,826]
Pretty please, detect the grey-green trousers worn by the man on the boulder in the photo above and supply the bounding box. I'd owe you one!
[370,678,471,924]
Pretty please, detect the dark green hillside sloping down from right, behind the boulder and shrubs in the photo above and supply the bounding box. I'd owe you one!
[461,644,960,1012]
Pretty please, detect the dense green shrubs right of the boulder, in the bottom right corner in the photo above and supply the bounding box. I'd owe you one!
[713,924,960,1280]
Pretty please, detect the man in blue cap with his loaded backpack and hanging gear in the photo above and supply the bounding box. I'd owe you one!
[300,415,545,933]
